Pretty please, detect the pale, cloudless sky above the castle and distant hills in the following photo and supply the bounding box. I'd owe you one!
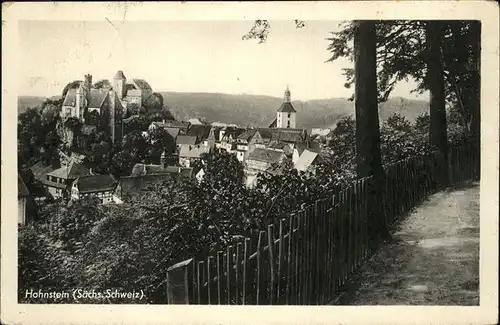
[19,20,421,100]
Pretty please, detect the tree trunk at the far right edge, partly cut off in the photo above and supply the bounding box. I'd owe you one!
[468,20,481,177]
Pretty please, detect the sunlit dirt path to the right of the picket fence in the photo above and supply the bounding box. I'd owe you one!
[338,183,479,305]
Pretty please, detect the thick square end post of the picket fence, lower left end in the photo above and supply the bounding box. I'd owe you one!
[167,258,194,305]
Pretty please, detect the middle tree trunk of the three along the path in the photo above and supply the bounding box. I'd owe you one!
[425,20,448,186]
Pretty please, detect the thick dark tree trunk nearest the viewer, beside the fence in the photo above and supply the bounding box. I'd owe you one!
[354,20,390,240]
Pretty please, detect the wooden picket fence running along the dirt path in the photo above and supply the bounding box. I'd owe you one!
[167,143,479,305]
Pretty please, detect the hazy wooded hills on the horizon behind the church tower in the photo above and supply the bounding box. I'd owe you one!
[18,92,429,129]
